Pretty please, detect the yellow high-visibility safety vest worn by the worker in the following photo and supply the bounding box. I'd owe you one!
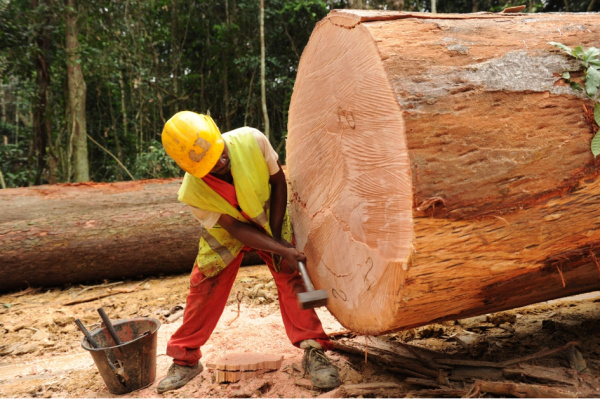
[179,127,292,277]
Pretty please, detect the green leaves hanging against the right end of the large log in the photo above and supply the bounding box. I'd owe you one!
[549,42,600,158]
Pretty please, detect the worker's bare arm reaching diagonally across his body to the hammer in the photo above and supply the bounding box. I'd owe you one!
[217,215,306,269]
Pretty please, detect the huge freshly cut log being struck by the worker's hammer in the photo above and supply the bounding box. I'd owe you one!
[287,11,600,334]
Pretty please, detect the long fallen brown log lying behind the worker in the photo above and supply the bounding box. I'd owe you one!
[0,179,262,292]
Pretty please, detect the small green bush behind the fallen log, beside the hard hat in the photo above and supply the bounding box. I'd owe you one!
[132,141,183,179]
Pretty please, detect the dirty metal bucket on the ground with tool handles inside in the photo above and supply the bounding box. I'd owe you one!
[81,318,160,394]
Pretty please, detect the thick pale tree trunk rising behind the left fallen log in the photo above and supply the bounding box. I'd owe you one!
[65,0,90,182]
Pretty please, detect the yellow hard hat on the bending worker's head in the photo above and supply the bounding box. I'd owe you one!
[162,111,225,178]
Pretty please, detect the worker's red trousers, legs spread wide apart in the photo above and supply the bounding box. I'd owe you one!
[167,248,333,366]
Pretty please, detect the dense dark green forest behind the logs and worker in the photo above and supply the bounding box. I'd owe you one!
[0,0,600,188]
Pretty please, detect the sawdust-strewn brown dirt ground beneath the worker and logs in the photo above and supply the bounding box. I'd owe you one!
[0,266,600,398]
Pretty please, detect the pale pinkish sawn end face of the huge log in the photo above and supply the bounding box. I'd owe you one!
[287,14,413,329]
